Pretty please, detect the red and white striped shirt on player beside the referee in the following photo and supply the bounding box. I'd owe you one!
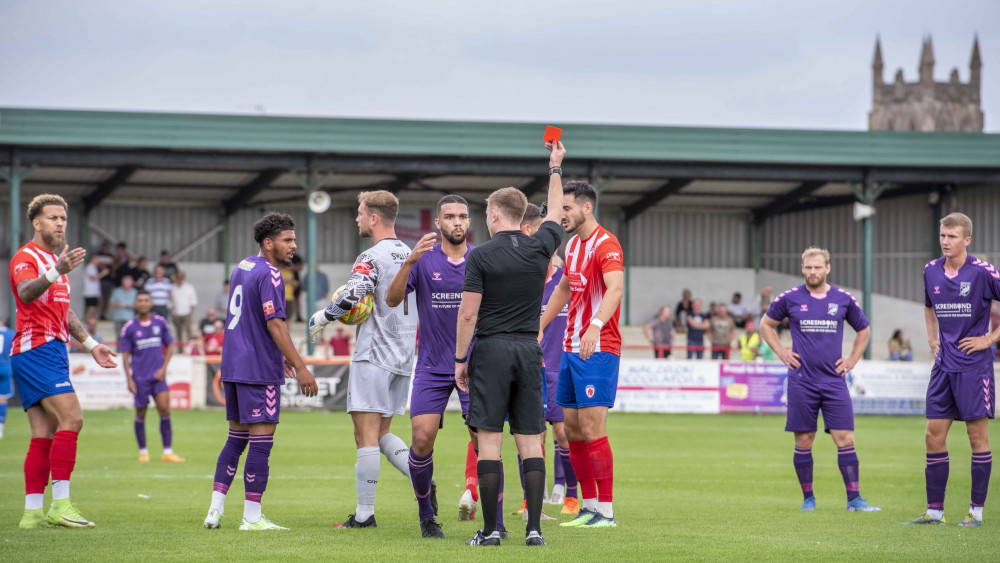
[563,225,625,356]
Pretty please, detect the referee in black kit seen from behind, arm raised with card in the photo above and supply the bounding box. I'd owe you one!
[455,141,566,545]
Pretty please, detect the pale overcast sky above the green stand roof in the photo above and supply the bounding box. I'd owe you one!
[0,0,1000,131]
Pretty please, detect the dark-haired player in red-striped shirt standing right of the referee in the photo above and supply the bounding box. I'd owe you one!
[539,182,625,528]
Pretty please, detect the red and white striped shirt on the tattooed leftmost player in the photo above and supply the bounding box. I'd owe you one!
[10,241,70,356]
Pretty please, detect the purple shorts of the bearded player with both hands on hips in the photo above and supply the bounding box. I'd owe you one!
[785,377,854,432]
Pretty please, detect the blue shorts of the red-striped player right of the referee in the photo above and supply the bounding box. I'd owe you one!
[556,352,621,409]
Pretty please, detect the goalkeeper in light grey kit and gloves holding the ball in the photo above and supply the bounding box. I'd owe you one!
[309,190,417,528]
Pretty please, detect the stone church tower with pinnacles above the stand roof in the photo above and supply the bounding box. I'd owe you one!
[868,36,983,132]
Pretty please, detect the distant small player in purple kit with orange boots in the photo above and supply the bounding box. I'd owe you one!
[120,289,184,463]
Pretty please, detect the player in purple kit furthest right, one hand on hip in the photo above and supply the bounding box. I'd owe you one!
[908,213,1000,528]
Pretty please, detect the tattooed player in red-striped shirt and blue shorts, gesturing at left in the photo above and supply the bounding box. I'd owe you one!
[9,194,117,528]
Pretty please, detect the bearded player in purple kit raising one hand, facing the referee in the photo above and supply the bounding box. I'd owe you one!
[385,195,488,538]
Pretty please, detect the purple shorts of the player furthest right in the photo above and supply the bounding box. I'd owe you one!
[927,363,996,421]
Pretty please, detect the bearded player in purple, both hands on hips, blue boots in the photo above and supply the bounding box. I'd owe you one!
[760,247,880,512]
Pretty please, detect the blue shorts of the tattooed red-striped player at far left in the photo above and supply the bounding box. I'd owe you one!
[10,340,74,410]
